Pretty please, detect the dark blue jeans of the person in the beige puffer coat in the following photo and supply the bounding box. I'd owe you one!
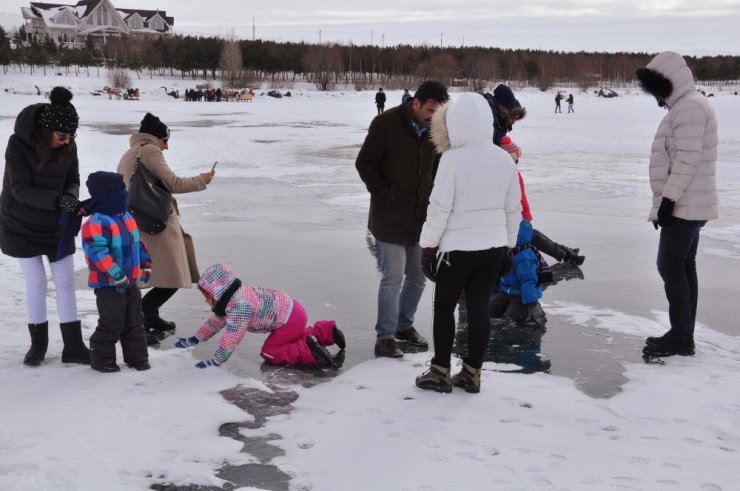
[658,218,707,341]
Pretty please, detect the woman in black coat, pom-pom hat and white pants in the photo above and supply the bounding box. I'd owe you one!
[0,87,90,366]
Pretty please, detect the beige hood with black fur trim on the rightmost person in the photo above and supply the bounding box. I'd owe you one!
[635,51,696,108]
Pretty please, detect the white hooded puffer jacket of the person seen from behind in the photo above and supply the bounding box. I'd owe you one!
[419,93,521,252]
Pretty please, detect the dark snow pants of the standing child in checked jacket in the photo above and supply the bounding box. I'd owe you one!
[90,286,149,368]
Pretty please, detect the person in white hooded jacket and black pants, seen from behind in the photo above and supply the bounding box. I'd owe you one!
[416,94,521,392]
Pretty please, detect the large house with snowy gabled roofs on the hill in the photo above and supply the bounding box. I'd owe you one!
[21,0,175,46]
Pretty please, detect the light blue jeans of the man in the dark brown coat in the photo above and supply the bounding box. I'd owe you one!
[375,240,426,340]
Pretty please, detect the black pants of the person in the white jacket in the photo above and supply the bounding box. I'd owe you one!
[432,247,506,368]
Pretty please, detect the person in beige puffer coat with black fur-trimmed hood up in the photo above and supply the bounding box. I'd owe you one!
[636,52,719,356]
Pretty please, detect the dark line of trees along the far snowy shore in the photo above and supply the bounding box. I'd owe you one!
[0,27,740,91]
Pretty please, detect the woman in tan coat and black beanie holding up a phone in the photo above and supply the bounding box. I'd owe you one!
[118,113,216,344]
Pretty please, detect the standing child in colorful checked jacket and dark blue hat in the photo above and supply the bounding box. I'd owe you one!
[82,171,152,372]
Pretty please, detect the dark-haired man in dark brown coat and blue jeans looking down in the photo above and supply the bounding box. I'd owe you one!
[355,81,449,358]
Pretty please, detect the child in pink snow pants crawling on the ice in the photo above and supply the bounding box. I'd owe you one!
[175,263,346,368]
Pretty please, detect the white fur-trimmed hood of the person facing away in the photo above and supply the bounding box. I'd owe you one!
[430,93,493,153]
